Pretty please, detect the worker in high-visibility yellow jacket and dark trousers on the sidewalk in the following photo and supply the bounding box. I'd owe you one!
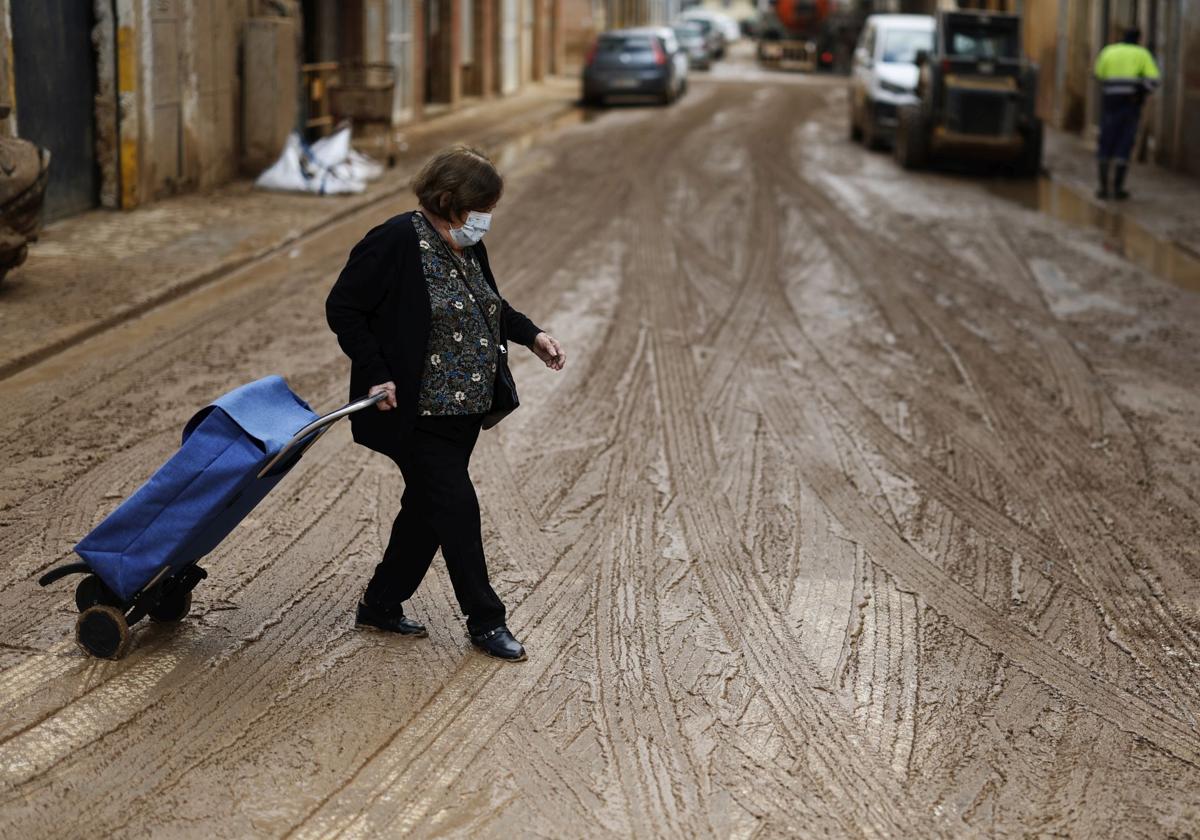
[1096,29,1158,198]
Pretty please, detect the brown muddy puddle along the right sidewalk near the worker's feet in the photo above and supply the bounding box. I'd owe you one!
[988,178,1200,292]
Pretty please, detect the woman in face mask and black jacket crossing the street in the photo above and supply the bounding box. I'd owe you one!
[325,146,566,661]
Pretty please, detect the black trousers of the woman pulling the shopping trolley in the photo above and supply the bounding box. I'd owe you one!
[364,414,505,634]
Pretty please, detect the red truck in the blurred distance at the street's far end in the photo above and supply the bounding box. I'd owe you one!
[758,0,874,72]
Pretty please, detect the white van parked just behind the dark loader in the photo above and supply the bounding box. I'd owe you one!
[850,14,936,149]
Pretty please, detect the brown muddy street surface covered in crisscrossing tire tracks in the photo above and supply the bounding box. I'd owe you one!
[0,55,1200,838]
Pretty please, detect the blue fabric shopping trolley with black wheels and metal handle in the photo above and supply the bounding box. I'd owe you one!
[38,376,385,659]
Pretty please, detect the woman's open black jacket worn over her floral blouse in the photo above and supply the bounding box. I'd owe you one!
[325,212,540,454]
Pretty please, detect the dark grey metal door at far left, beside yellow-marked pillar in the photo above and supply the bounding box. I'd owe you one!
[10,0,100,220]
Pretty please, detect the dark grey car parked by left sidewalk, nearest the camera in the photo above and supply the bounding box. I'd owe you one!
[583,26,688,104]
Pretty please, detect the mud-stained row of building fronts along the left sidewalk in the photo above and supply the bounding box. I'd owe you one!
[0,0,565,220]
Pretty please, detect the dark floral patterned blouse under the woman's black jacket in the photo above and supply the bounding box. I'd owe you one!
[413,212,505,415]
